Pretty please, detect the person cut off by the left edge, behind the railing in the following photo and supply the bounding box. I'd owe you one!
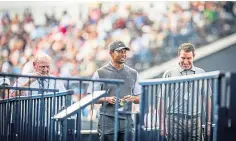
[0,77,10,100]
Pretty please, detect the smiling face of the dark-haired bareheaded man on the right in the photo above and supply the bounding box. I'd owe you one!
[179,50,194,70]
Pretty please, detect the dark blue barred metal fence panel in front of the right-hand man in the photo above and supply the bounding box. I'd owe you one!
[139,72,226,141]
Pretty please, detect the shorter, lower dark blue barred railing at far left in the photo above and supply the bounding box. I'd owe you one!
[0,91,73,141]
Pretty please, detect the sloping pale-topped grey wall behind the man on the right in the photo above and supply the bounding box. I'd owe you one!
[139,33,236,80]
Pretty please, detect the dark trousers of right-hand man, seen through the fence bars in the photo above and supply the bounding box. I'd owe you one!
[165,115,203,141]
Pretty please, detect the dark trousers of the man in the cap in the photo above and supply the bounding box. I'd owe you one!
[98,115,133,141]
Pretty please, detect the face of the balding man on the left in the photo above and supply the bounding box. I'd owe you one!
[34,61,50,76]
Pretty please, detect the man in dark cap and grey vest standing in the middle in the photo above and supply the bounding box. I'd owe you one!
[87,41,141,141]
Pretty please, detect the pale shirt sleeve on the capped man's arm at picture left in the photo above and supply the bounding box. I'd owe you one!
[87,71,101,94]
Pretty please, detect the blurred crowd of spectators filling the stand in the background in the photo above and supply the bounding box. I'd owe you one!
[0,1,236,77]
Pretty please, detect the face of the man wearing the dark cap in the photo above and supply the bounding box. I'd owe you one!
[111,49,127,64]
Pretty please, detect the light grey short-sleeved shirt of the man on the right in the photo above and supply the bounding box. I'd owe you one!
[159,65,209,115]
